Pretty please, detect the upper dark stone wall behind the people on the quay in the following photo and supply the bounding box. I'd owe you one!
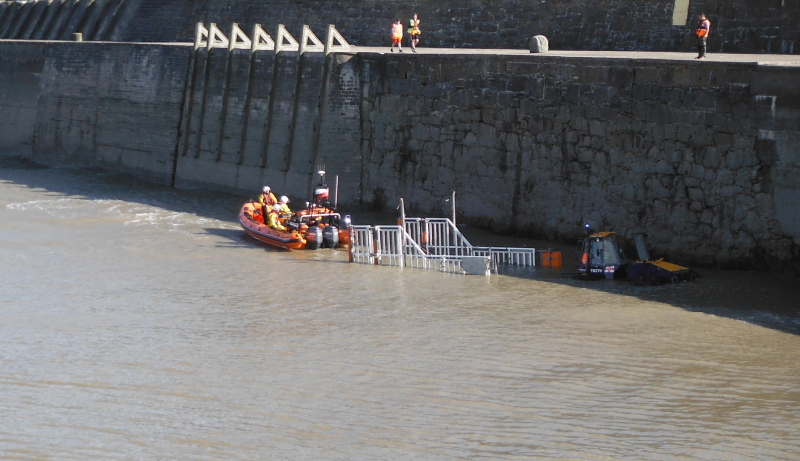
[0,0,800,54]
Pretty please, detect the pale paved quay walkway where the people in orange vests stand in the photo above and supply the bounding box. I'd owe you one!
[352,46,800,67]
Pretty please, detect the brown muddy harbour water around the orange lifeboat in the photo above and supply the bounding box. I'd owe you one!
[0,159,800,460]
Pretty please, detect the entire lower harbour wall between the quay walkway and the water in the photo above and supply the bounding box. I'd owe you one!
[0,42,800,268]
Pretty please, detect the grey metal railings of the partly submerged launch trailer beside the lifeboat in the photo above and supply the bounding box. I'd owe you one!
[350,218,537,273]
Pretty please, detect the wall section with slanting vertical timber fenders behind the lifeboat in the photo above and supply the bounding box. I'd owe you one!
[175,49,362,203]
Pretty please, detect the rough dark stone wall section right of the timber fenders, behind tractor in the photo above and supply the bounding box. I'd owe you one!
[361,55,800,267]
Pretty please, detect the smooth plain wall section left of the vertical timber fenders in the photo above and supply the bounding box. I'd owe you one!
[0,42,191,184]
